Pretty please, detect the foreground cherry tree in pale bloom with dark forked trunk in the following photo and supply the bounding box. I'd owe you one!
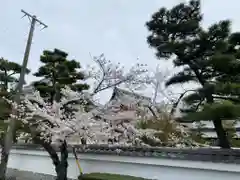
[7,88,160,180]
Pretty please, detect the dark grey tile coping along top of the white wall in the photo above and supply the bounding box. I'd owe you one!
[9,144,240,164]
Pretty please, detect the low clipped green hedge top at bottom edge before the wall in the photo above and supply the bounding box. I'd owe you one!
[78,173,146,180]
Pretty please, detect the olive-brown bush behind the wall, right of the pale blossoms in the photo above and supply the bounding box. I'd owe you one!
[138,109,196,147]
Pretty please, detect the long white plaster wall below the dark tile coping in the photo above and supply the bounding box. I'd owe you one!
[6,150,240,180]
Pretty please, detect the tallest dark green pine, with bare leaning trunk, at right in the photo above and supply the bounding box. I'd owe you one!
[146,0,240,148]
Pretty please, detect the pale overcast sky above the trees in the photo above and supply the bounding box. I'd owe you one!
[0,0,240,102]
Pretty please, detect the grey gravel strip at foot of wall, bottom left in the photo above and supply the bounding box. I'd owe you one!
[7,169,75,180]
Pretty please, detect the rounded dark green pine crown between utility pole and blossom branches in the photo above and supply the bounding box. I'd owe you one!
[34,49,89,102]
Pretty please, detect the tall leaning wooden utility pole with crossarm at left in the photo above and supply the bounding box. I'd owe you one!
[0,10,47,180]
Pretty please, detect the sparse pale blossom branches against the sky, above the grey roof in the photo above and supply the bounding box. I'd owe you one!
[87,54,148,94]
